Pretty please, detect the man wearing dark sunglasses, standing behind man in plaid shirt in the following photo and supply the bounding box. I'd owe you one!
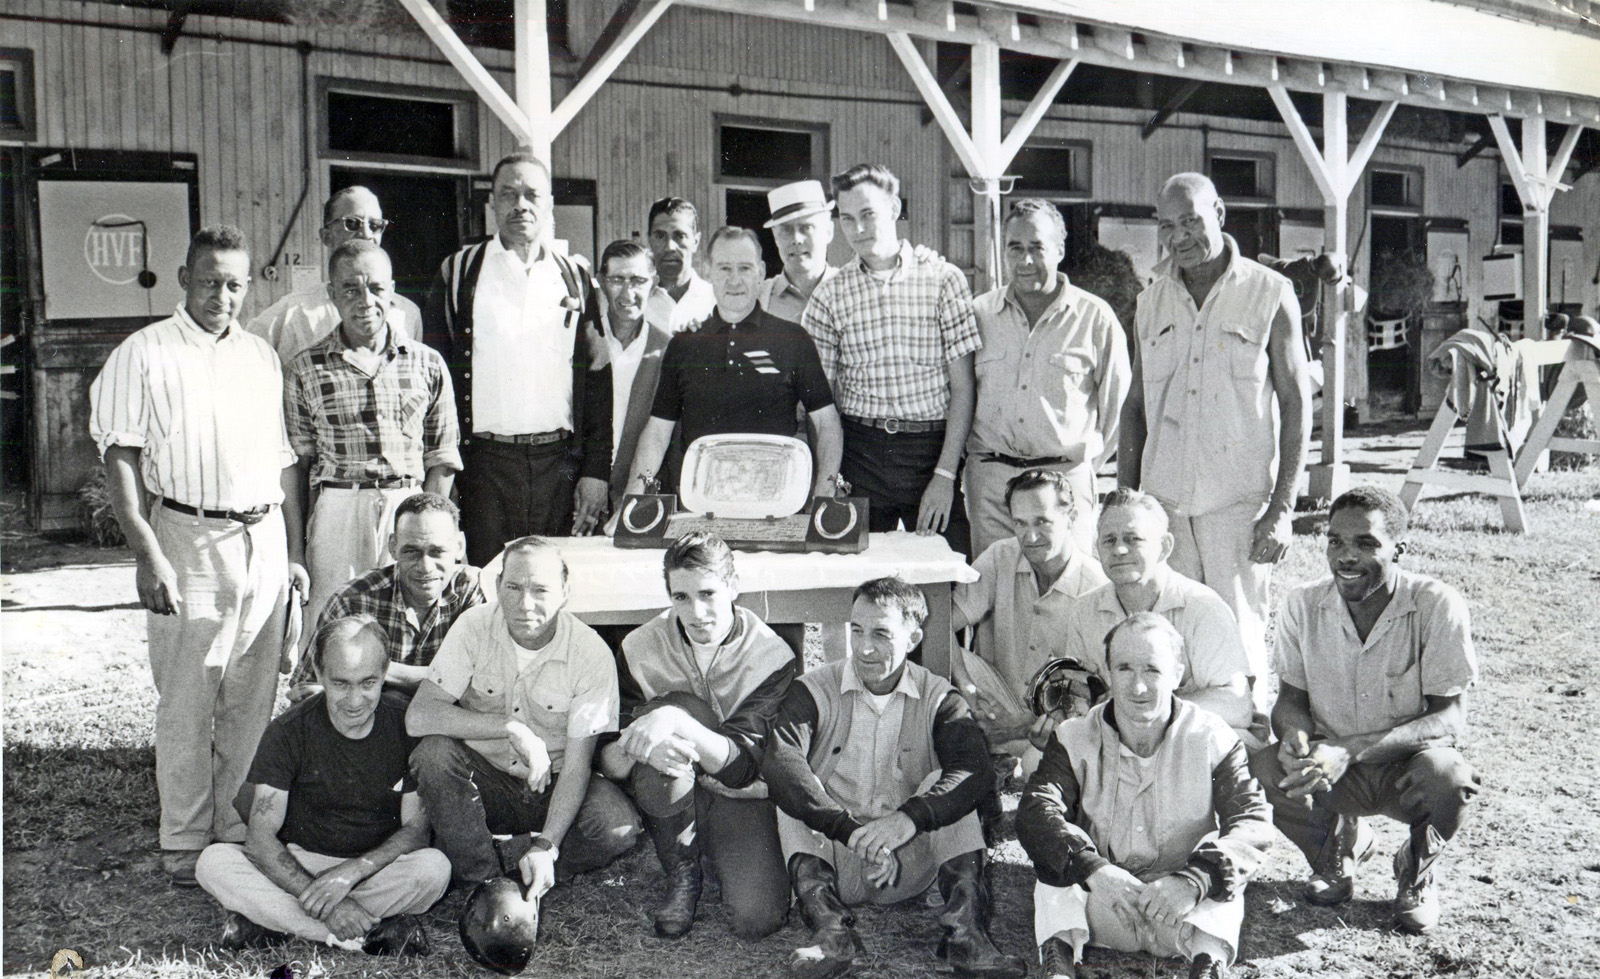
[245,186,422,371]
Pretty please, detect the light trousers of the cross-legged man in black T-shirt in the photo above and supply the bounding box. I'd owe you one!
[195,843,450,945]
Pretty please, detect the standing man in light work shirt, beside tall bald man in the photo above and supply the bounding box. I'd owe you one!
[965,198,1130,553]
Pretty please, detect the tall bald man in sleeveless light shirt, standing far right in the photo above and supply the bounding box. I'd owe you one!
[1117,173,1310,707]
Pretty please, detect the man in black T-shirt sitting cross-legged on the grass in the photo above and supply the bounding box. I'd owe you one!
[195,616,450,955]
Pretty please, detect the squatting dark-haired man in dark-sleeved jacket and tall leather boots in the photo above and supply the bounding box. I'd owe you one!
[763,577,1027,979]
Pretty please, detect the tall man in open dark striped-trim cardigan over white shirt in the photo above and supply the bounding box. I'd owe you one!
[424,154,611,566]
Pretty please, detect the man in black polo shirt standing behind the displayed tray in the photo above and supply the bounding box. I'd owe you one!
[629,227,843,494]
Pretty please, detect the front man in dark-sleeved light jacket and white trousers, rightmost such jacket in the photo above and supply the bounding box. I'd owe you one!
[1016,613,1272,979]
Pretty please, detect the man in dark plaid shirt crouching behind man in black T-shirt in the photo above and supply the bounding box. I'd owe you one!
[290,493,486,702]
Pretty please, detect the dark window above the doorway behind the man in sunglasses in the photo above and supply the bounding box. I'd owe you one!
[320,78,478,170]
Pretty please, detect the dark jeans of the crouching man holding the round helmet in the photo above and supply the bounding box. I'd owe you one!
[411,734,643,883]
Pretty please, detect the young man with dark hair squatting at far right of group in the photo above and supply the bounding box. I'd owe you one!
[1250,486,1478,933]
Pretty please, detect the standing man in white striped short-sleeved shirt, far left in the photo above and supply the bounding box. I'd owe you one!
[90,226,307,888]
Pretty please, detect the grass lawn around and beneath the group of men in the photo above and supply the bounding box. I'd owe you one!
[0,470,1600,979]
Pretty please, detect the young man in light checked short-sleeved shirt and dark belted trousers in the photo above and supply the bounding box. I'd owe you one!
[800,163,982,553]
